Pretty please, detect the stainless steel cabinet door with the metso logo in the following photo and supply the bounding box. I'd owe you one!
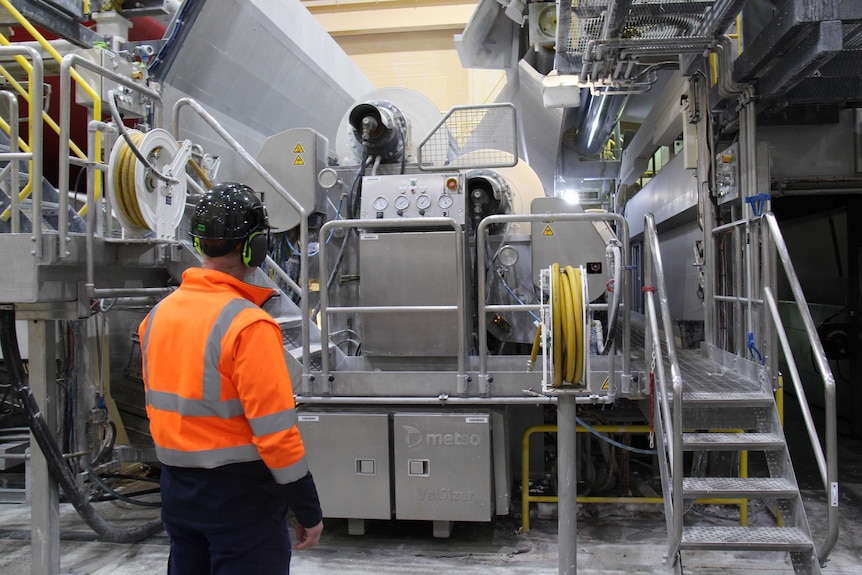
[392,413,493,521]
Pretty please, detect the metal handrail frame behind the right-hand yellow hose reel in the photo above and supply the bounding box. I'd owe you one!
[476,213,632,394]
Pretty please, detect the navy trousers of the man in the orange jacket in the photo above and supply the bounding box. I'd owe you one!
[165,515,290,575]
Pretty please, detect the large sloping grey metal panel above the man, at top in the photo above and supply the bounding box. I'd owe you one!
[157,0,374,183]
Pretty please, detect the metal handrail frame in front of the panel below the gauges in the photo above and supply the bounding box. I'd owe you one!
[318,218,467,395]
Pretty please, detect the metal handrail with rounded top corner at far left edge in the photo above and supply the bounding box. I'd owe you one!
[0,46,44,255]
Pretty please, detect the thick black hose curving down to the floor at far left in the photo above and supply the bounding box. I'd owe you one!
[0,309,163,543]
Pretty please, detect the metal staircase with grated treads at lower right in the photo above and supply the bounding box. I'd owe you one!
[674,360,820,574]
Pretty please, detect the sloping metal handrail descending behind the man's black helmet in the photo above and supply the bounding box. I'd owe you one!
[173,98,312,386]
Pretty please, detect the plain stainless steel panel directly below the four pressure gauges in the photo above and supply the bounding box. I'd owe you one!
[359,232,460,357]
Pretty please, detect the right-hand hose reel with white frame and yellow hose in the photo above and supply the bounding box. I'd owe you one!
[541,263,590,389]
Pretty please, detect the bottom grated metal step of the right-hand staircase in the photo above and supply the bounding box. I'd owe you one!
[680,527,814,553]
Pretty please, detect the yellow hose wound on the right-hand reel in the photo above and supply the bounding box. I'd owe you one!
[551,264,585,387]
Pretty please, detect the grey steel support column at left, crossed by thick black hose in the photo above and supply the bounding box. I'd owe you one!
[27,319,60,575]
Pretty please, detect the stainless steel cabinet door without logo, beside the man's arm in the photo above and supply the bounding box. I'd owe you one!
[298,411,392,519]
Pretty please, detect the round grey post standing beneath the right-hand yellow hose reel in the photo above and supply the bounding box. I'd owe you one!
[557,394,578,575]
